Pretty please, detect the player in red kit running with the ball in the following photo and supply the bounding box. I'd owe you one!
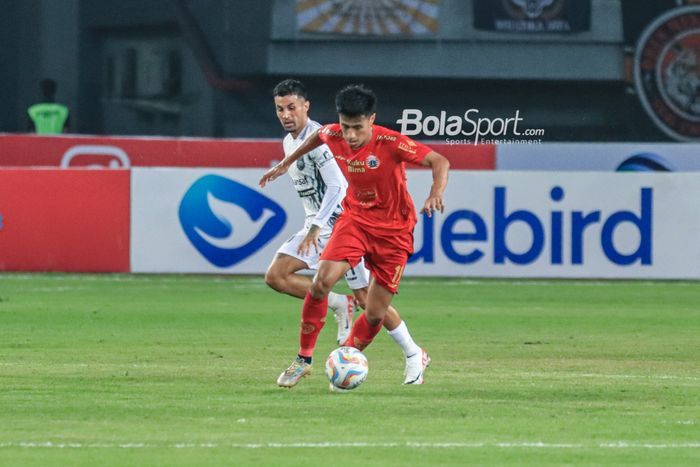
[260,85,449,384]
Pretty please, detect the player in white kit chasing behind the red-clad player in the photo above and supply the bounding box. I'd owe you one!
[265,79,424,388]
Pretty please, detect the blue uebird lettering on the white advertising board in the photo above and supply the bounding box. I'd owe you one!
[409,186,654,266]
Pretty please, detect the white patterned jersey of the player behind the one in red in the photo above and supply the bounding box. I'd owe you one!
[282,120,348,235]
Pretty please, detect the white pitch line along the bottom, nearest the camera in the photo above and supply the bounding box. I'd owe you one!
[0,441,700,449]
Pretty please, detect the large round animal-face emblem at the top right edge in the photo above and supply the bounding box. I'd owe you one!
[634,6,700,141]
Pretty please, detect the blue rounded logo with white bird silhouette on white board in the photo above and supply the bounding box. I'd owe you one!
[179,175,287,268]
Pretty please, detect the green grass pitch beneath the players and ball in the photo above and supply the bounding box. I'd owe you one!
[0,274,700,466]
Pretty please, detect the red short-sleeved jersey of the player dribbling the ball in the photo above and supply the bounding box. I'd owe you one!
[318,123,432,230]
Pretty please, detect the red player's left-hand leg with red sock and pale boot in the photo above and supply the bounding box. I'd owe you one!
[277,261,350,388]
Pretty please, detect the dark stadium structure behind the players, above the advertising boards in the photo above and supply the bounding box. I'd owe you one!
[0,0,692,142]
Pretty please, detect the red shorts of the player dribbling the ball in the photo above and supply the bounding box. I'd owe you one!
[321,215,413,293]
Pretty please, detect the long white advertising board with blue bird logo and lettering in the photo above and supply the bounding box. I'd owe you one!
[131,168,700,279]
